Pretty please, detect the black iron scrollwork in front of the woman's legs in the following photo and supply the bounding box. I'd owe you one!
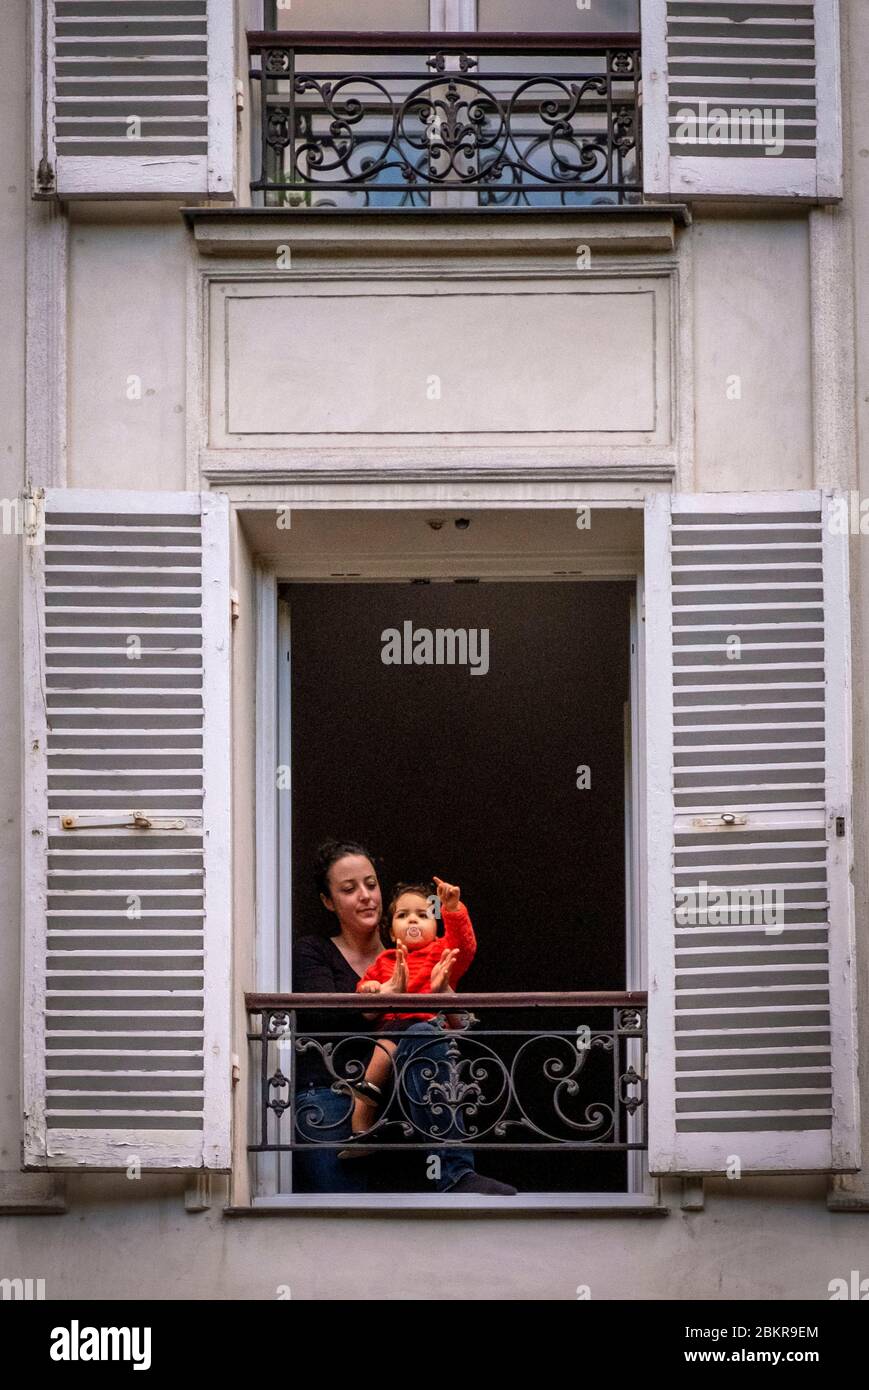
[263,1008,645,1148]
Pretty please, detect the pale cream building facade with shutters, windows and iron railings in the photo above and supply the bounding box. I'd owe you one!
[0,0,869,1300]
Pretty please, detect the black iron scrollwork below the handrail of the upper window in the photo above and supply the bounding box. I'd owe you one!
[254,49,641,206]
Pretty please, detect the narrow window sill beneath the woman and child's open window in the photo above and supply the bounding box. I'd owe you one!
[224,1193,669,1216]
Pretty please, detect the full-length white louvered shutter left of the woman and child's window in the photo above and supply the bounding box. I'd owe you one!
[22,489,231,1169]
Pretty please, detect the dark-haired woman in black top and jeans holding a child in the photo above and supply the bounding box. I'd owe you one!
[293,840,516,1197]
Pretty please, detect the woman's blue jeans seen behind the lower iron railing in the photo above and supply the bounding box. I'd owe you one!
[293,1019,474,1193]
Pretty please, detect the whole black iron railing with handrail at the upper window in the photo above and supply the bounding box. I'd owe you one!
[247,33,642,209]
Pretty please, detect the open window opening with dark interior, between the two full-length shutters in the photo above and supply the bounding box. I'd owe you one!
[246,509,647,1201]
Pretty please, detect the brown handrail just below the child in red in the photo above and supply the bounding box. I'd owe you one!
[245,990,648,1013]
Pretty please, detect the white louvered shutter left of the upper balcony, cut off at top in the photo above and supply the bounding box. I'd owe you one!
[32,0,235,197]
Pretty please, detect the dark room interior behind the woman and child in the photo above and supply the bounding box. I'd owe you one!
[284,582,631,1191]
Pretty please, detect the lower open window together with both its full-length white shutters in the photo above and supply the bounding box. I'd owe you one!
[22,489,859,1201]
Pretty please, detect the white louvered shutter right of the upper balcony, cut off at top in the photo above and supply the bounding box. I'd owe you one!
[641,0,843,202]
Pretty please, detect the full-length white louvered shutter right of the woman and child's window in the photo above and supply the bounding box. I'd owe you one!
[645,492,859,1173]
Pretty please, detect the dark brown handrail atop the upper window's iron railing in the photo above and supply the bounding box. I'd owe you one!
[247,29,640,54]
